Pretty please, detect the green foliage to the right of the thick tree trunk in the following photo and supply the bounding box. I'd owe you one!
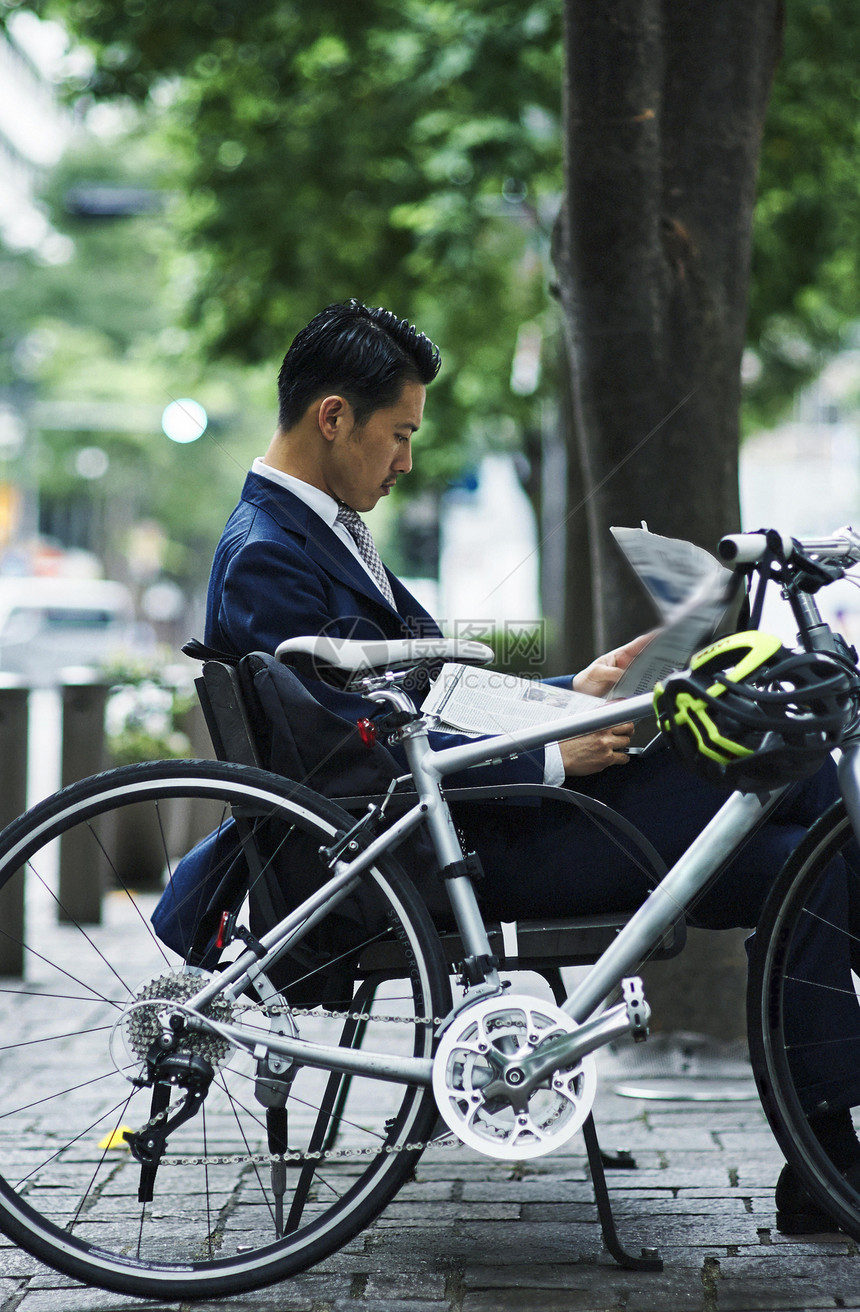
[747,0,860,424]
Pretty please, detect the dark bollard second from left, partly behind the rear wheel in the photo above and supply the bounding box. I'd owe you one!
[59,670,108,925]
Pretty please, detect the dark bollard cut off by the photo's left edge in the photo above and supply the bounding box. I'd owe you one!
[0,674,30,976]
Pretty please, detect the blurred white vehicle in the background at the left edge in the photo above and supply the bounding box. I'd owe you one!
[0,577,151,685]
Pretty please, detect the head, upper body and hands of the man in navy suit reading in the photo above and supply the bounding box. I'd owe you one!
[206,306,641,783]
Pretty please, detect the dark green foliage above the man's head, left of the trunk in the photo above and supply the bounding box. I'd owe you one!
[3,0,561,485]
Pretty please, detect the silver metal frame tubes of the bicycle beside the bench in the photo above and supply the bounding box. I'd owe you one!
[179,694,798,1086]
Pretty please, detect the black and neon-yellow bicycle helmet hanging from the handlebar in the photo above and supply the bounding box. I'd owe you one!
[654,630,856,792]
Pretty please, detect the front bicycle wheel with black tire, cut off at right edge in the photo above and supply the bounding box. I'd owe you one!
[747,802,860,1239]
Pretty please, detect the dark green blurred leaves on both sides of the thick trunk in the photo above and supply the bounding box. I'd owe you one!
[0,0,860,485]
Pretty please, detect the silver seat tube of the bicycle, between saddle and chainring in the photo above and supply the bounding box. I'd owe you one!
[403,726,495,979]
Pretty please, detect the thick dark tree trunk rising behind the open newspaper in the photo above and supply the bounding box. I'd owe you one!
[555,0,781,649]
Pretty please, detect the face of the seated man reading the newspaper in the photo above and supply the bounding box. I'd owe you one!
[326,383,425,510]
